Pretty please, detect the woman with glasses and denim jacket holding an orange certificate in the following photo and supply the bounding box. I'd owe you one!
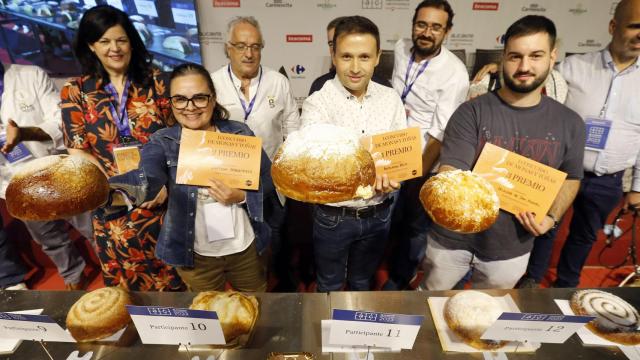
[109,64,275,292]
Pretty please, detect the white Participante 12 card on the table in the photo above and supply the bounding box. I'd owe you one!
[481,312,595,344]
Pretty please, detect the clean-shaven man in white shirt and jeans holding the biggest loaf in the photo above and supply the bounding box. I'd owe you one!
[301,16,406,292]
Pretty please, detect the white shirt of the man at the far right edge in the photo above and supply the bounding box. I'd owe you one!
[558,49,640,191]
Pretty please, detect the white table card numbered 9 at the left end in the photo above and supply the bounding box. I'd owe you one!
[0,312,76,342]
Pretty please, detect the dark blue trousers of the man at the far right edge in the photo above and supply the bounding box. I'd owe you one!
[555,171,623,287]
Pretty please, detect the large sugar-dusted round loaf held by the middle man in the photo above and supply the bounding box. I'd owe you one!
[271,124,376,204]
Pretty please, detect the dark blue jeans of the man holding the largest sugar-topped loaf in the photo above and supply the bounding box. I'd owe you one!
[313,201,392,292]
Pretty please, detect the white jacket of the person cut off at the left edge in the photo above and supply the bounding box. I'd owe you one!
[0,65,64,198]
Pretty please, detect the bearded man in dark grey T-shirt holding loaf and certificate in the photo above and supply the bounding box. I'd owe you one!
[423,15,585,290]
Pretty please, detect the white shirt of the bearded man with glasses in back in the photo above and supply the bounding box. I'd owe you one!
[391,39,469,149]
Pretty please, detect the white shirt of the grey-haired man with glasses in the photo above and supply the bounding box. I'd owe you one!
[211,65,300,161]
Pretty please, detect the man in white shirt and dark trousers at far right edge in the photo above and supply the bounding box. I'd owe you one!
[544,0,640,287]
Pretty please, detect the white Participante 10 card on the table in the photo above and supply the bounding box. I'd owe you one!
[127,305,225,345]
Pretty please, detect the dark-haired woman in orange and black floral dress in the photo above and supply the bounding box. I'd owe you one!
[61,6,184,291]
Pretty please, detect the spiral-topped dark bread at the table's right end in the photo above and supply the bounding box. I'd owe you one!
[570,289,640,345]
